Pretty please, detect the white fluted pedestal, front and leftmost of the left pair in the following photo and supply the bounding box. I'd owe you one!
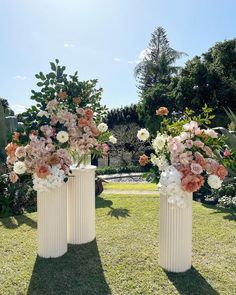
[37,184,67,258]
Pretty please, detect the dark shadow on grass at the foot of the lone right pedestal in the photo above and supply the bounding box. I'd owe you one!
[166,267,220,295]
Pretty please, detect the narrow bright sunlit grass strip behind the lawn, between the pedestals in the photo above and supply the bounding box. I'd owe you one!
[103,182,157,191]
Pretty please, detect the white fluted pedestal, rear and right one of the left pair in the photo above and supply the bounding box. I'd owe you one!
[67,166,96,244]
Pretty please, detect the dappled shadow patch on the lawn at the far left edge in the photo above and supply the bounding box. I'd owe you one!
[1,215,37,229]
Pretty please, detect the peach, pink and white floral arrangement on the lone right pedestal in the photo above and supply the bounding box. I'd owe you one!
[137,106,228,207]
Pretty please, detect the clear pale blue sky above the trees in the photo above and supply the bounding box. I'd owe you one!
[0,0,236,112]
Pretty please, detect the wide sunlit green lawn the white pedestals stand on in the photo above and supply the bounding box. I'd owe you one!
[0,185,236,295]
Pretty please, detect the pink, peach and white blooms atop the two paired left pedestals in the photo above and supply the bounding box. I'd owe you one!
[6,91,116,192]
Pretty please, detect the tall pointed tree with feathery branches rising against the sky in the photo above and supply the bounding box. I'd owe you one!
[134,27,186,91]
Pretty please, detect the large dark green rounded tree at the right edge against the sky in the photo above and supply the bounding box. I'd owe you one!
[175,39,236,123]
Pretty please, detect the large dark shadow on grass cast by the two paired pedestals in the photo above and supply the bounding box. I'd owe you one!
[27,240,111,295]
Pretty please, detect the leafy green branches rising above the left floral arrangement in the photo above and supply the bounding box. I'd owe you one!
[20,59,107,131]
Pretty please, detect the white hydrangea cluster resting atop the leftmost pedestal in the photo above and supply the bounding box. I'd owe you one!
[33,166,65,192]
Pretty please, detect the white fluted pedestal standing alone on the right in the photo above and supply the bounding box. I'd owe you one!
[159,193,192,272]
